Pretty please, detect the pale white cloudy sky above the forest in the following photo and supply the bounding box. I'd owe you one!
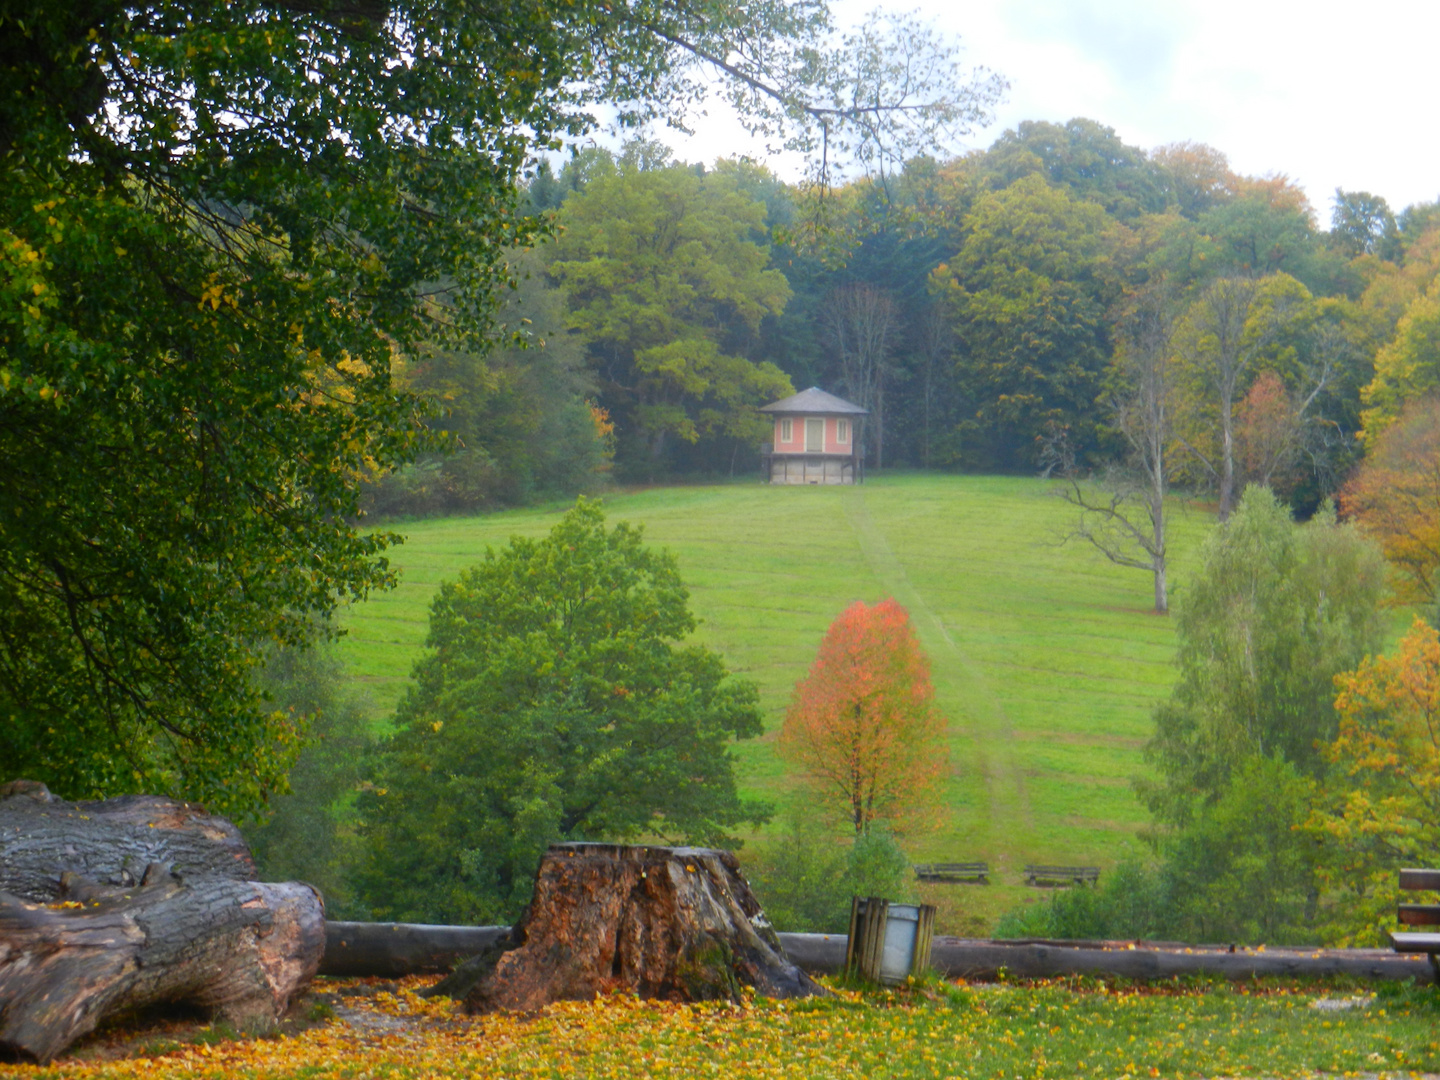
[665,0,1440,228]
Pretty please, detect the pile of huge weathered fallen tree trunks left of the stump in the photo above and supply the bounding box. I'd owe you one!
[0,782,325,1063]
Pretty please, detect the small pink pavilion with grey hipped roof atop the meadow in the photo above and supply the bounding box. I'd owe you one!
[760,386,868,484]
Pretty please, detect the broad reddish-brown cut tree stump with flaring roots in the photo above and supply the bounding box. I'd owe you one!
[436,844,827,1012]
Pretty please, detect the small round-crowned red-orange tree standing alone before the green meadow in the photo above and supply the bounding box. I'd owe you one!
[780,599,948,835]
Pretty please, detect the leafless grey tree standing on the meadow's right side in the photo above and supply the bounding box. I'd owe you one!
[1043,285,1175,615]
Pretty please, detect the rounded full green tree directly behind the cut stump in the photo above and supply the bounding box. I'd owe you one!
[360,500,768,922]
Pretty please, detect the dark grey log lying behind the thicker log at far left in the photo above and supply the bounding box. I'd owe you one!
[0,780,255,901]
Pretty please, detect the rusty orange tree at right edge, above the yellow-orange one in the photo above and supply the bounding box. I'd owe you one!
[1341,399,1440,603]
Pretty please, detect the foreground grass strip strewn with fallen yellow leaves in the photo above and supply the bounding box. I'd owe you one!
[0,979,1440,1080]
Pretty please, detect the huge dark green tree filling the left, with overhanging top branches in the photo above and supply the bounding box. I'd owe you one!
[0,0,998,811]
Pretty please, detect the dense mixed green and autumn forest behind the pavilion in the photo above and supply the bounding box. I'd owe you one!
[373,120,1440,513]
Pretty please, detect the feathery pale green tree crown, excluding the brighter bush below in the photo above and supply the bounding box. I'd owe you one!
[1146,487,1385,825]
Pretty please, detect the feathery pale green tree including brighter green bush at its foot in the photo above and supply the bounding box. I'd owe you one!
[1140,487,1387,942]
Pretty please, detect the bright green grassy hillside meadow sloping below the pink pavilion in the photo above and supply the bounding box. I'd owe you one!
[340,475,1214,930]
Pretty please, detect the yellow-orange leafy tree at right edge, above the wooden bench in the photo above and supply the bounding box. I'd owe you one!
[1305,618,1440,945]
